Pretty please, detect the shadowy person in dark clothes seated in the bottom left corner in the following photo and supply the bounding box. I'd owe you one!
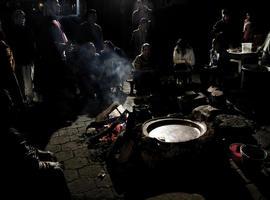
[0,89,71,200]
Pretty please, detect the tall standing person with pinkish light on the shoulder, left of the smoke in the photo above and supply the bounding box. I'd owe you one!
[35,0,76,118]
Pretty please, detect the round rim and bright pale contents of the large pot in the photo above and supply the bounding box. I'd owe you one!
[143,118,207,143]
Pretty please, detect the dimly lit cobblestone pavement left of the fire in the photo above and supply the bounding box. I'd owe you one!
[47,115,122,200]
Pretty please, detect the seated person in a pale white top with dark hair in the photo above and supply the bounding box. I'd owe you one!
[173,39,195,84]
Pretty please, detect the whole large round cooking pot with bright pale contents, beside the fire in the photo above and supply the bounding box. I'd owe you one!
[140,117,212,165]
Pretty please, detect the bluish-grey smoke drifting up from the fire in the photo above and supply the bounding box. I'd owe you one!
[75,44,132,108]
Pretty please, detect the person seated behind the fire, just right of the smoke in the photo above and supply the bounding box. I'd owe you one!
[132,43,153,94]
